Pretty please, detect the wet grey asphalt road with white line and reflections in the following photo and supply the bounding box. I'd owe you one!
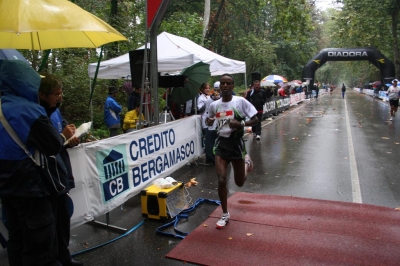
[0,90,400,266]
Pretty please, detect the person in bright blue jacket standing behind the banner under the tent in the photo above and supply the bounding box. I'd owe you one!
[104,87,122,137]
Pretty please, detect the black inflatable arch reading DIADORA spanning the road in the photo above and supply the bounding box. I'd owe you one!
[303,48,395,88]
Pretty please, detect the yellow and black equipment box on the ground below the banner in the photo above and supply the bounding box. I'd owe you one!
[140,182,187,221]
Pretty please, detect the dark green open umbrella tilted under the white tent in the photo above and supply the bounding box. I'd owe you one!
[171,61,211,104]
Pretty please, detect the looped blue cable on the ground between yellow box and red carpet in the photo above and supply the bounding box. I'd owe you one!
[156,199,221,239]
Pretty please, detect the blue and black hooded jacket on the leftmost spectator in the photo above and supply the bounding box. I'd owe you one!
[0,60,63,197]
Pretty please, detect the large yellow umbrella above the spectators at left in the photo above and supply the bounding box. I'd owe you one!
[0,0,127,50]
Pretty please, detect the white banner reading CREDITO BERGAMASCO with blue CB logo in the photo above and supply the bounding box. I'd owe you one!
[69,116,203,228]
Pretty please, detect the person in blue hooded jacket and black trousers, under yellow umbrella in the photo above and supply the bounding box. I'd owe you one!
[0,60,63,265]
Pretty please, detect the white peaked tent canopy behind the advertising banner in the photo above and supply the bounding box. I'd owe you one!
[88,32,246,79]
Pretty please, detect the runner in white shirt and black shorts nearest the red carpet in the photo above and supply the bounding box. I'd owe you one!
[206,74,258,228]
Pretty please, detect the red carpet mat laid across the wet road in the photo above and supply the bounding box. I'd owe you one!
[167,192,400,266]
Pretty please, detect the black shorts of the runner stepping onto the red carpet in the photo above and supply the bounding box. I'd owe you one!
[213,136,247,161]
